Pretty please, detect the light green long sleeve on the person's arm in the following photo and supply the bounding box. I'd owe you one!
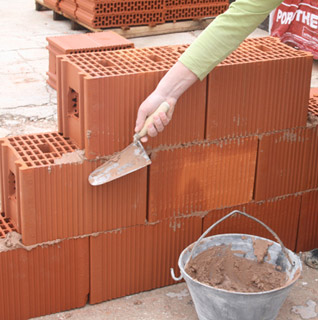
[179,0,282,80]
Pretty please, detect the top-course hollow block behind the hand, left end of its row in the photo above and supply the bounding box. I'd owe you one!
[57,46,206,159]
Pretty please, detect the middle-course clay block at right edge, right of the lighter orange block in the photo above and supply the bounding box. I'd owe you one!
[255,127,318,200]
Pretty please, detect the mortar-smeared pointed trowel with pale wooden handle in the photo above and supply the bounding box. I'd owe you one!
[88,102,170,186]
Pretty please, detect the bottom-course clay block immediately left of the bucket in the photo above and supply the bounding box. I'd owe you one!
[90,217,202,304]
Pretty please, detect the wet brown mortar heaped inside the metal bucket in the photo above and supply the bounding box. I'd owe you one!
[185,245,287,292]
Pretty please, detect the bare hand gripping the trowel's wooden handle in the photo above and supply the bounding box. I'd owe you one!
[135,91,176,142]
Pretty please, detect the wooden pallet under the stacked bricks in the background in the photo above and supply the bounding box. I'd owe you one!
[35,0,214,39]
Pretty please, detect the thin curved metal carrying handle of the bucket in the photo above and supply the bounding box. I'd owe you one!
[170,210,296,281]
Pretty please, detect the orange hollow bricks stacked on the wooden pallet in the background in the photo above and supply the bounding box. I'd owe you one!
[56,0,229,28]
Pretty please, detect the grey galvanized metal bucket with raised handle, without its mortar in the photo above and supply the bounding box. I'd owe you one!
[171,210,302,320]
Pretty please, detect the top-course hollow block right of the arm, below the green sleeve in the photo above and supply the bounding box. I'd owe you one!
[206,37,312,140]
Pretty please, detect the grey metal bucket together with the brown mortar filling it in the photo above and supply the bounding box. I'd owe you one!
[171,210,302,320]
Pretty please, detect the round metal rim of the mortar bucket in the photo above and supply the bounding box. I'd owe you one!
[178,233,302,296]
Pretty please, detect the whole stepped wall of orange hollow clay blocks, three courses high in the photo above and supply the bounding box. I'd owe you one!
[0,37,318,319]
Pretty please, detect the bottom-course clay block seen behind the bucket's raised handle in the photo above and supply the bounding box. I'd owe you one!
[203,196,301,251]
